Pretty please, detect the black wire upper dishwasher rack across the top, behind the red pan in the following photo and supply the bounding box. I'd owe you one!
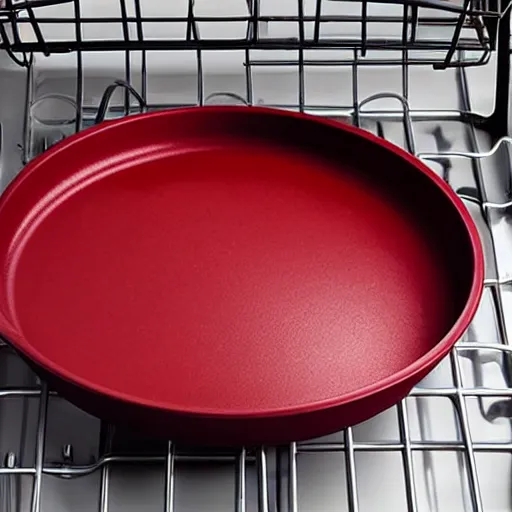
[0,0,510,68]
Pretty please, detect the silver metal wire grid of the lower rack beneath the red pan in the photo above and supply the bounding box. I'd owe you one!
[0,16,512,512]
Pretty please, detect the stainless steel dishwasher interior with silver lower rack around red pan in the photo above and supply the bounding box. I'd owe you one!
[0,0,512,512]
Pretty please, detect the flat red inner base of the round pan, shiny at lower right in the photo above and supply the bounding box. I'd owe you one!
[11,136,454,414]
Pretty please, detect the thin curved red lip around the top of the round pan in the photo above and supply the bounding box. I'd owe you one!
[0,106,484,419]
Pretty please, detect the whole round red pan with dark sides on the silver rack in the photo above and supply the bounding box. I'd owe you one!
[0,107,483,445]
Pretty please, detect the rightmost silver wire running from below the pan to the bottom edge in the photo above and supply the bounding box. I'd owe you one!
[450,350,483,512]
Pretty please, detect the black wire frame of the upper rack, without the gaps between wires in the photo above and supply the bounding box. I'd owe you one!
[0,0,510,69]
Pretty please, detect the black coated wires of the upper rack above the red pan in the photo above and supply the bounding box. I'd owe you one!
[0,0,498,70]
